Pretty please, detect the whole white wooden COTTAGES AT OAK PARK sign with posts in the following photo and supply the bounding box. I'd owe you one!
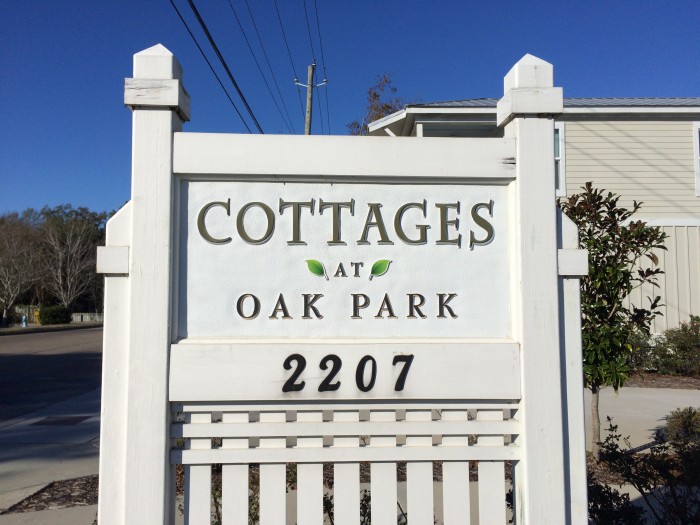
[99,46,586,525]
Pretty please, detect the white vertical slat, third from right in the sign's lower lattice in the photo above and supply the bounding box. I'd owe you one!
[405,410,434,525]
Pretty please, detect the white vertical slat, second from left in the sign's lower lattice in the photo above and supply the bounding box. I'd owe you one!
[221,412,249,525]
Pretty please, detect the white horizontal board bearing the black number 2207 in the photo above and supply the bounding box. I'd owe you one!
[170,340,520,401]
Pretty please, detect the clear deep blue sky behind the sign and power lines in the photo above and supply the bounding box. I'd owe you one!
[0,0,700,214]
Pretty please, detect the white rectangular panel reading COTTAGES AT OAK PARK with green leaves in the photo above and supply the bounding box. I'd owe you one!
[178,180,510,340]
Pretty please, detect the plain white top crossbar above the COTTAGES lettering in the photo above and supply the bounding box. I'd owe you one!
[173,133,516,183]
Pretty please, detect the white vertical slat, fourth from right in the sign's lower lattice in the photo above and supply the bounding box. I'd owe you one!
[367,410,398,524]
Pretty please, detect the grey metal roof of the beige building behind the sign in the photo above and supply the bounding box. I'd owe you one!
[406,97,700,108]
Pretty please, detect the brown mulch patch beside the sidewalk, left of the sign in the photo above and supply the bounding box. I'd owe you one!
[2,474,99,514]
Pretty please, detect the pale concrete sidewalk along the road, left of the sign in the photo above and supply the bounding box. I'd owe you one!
[0,388,100,525]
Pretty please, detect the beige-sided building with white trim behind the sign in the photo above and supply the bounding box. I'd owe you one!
[369,98,700,332]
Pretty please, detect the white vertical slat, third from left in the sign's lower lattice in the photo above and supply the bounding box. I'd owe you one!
[260,412,287,525]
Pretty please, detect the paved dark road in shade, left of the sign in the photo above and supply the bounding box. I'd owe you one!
[0,328,102,422]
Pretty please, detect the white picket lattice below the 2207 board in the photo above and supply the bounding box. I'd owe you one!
[171,401,520,525]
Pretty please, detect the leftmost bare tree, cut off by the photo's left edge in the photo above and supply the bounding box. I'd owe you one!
[0,214,37,325]
